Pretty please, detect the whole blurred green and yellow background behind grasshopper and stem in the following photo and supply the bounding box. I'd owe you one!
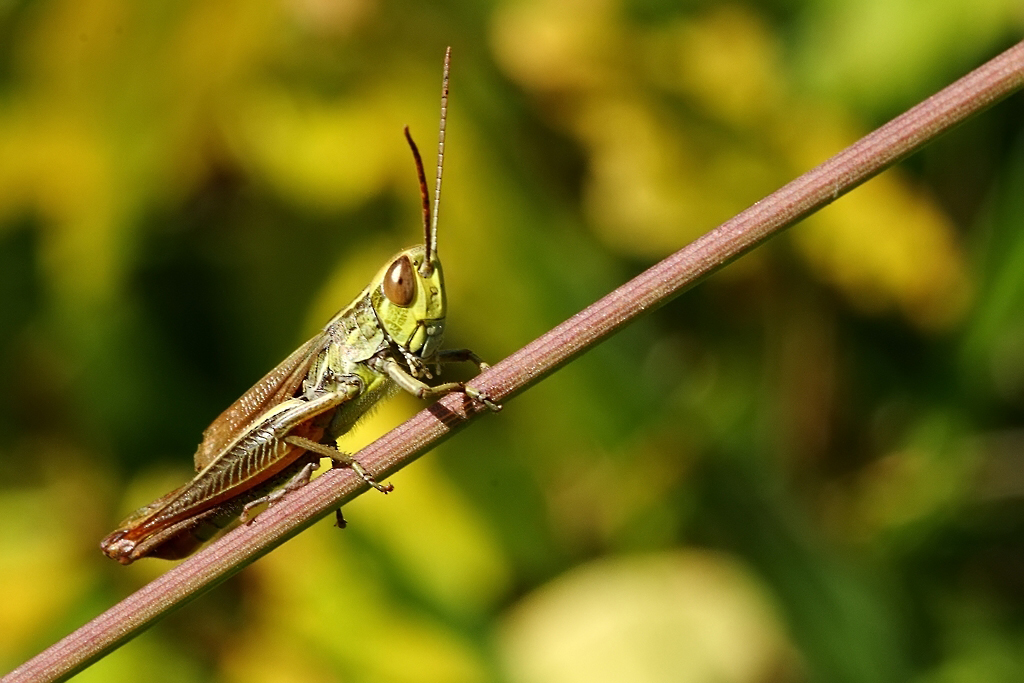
[0,0,1024,683]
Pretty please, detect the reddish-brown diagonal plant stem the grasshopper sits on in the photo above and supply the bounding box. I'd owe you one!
[3,42,1024,683]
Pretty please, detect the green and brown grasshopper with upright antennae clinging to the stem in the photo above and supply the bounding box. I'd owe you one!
[100,48,501,564]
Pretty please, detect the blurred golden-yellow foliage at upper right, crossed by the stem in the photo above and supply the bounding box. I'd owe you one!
[494,0,972,328]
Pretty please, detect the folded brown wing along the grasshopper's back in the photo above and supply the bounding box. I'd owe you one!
[195,332,328,472]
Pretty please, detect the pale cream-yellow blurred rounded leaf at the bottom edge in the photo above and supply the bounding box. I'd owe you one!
[501,550,799,683]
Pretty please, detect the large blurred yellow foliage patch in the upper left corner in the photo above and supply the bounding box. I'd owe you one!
[0,0,399,307]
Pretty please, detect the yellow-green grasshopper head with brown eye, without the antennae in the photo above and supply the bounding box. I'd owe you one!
[370,247,446,359]
